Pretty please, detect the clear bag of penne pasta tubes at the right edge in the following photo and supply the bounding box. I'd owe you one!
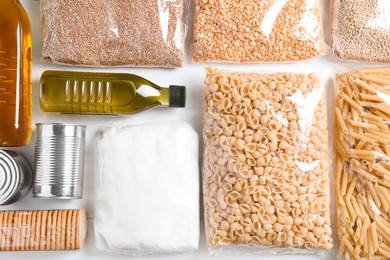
[334,68,390,259]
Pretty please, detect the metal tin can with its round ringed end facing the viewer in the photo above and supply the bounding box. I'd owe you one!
[0,150,33,205]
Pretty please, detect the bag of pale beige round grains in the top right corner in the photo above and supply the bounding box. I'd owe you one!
[331,0,390,62]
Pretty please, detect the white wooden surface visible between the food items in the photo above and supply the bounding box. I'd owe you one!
[0,0,388,260]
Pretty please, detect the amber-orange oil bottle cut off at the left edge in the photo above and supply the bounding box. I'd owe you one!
[0,0,32,146]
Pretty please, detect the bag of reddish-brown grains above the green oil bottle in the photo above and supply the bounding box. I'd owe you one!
[41,0,185,67]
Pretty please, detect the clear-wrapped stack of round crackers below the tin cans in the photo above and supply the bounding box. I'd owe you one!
[0,209,87,251]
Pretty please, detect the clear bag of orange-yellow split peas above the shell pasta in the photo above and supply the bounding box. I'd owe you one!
[193,0,324,63]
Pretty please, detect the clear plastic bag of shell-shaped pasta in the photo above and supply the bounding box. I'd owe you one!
[203,69,333,253]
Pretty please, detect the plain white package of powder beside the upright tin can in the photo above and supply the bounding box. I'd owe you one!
[94,122,199,255]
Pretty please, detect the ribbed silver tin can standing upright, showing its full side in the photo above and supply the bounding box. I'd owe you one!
[33,123,86,199]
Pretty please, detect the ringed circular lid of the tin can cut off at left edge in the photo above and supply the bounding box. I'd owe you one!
[0,150,20,205]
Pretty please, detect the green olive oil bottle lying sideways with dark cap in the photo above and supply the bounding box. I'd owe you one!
[39,71,186,115]
